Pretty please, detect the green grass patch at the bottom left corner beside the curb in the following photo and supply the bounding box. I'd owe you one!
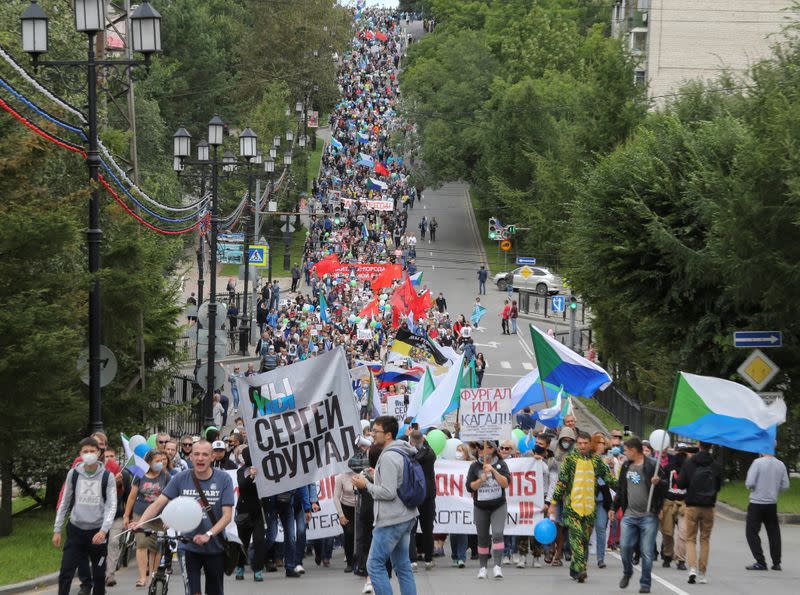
[0,506,61,585]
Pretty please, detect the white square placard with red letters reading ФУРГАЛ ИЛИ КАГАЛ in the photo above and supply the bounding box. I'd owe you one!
[459,388,512,442]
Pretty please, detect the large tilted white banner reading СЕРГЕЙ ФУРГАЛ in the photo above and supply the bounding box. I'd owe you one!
[237,347,361,498]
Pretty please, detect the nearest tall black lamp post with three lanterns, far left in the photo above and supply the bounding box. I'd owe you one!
[20,0,161,432]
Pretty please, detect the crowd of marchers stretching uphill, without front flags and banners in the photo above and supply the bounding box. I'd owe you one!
[53,12,788,595]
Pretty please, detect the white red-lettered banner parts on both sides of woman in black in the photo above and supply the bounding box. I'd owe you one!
[433,457,548,535]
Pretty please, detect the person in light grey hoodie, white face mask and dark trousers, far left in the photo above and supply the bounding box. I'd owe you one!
[52,437,117,595]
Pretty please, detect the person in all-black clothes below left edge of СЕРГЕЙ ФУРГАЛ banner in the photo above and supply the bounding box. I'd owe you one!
[235,448,267,583]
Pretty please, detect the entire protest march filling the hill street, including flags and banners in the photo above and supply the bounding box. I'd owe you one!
[48,3,788,595]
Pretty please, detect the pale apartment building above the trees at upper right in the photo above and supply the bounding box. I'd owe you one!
[611,0,800,106]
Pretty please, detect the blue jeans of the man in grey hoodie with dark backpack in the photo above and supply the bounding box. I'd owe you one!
[367,519,417,595]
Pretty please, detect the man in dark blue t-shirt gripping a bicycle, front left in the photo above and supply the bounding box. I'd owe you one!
[129,440,234,595]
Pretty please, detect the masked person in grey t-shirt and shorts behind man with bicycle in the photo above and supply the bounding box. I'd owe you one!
[122,449,170,587]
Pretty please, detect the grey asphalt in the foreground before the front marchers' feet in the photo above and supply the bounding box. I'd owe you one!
[38,508,800,595]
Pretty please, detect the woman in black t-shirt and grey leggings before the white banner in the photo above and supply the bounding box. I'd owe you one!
[467,440,511,579]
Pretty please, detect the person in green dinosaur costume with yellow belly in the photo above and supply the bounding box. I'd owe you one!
[545,432,617,583]
